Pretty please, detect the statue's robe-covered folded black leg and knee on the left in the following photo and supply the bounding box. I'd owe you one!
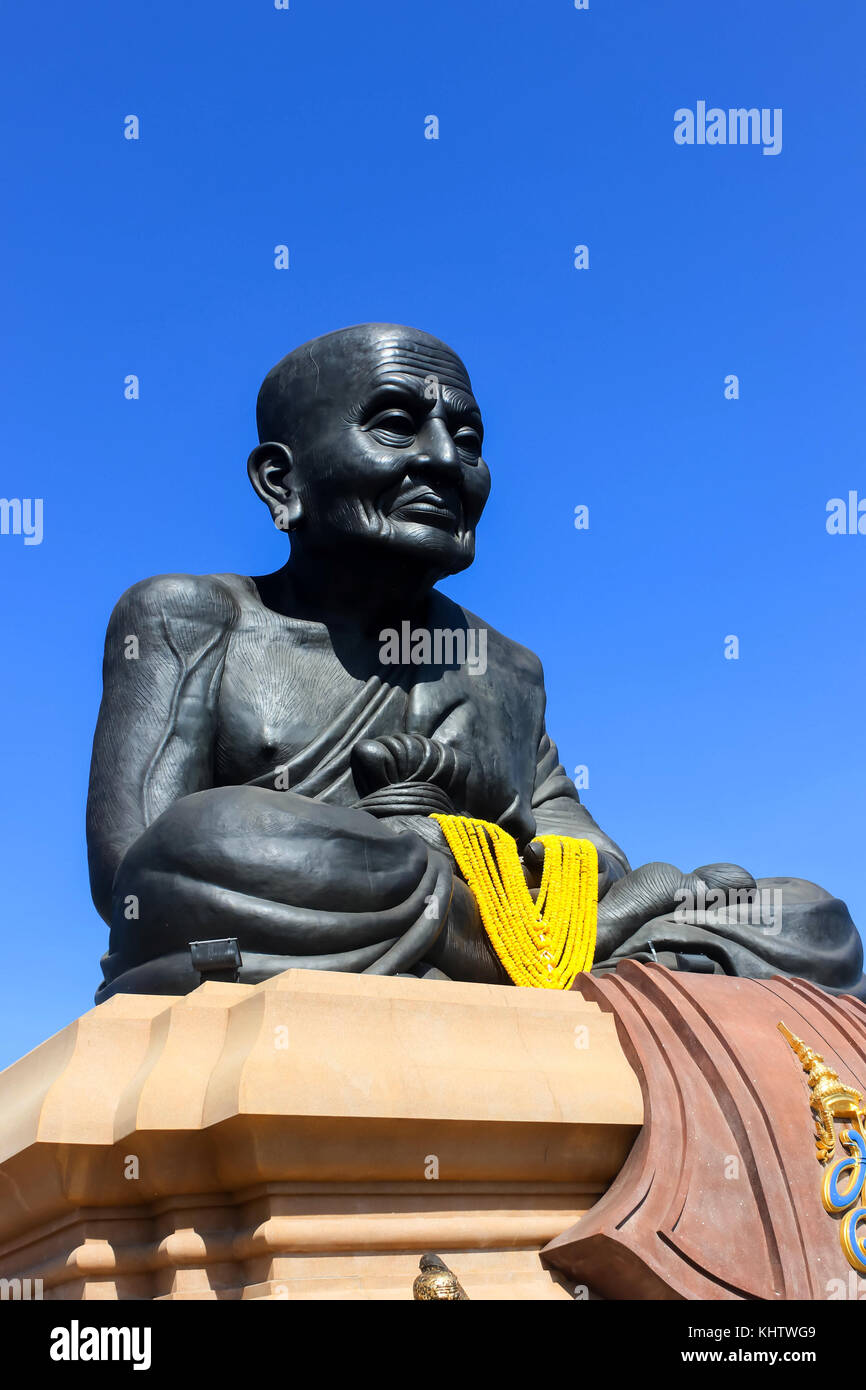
[97,787,453,1002]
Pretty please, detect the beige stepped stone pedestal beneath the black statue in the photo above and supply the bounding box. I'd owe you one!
[0,970,644,1300]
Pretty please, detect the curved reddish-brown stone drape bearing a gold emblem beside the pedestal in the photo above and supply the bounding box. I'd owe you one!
[544,962,866,1300]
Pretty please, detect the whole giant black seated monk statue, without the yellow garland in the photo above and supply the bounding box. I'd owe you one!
[88,324,865,1001]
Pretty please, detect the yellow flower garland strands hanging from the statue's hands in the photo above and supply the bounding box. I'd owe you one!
[432,815,598,990]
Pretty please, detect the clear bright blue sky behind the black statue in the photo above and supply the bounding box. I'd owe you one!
[0,0,866,1063]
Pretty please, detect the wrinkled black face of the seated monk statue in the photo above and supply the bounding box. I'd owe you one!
[276,325,491,574]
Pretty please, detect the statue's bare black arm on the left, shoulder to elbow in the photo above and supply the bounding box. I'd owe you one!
[88,574,236,920]
